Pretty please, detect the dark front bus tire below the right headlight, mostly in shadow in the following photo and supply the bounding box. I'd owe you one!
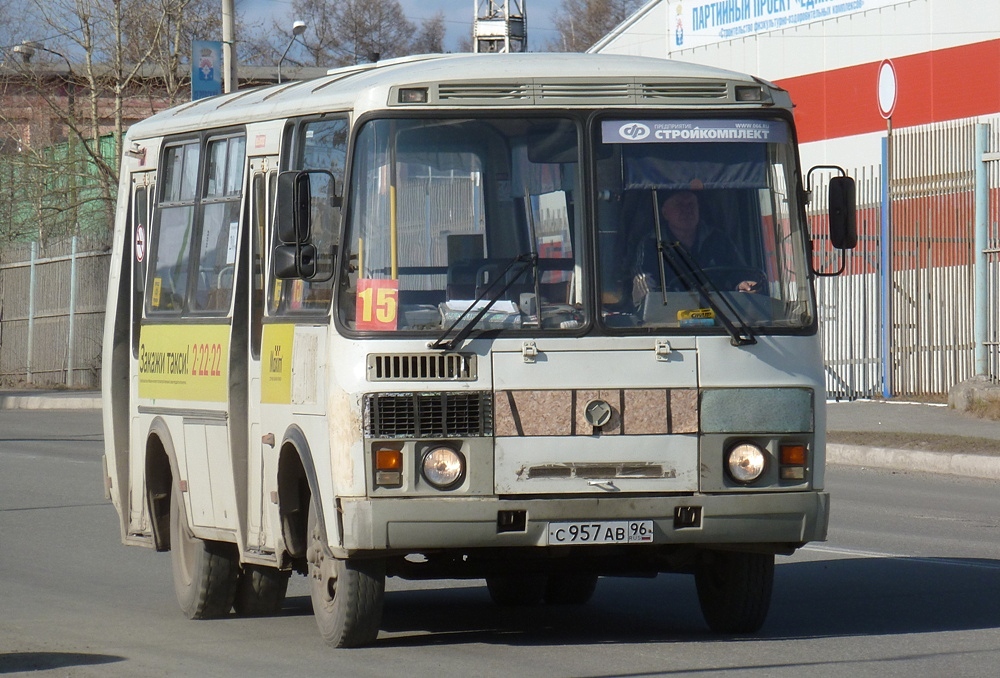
[694,551,774,634]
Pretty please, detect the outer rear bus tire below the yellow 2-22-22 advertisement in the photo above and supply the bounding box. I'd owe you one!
[170,484,240,619]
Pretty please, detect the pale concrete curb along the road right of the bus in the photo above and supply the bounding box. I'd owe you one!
[826,443,1000,480]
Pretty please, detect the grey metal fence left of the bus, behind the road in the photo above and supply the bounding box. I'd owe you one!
[0,238,110,388]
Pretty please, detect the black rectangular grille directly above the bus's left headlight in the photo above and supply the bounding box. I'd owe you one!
[364,391,493,438]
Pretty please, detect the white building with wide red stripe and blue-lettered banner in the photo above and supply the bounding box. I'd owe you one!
[591,0,1000,167]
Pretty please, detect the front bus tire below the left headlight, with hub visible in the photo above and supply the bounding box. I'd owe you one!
[307,501,385,647]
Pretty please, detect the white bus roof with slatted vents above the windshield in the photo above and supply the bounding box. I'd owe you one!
[128,53,791,139]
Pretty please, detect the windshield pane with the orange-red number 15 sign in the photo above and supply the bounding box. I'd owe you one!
[339,117,586,334]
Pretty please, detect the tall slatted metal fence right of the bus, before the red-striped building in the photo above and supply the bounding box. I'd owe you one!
[813,121,1000,399]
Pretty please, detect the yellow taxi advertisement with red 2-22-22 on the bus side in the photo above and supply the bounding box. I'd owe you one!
[139,325,229,402]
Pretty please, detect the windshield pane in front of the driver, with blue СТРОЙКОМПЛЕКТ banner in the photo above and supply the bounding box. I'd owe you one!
[594,118,815,339]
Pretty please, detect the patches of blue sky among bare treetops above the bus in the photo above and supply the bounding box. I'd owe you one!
[235,0,562,52]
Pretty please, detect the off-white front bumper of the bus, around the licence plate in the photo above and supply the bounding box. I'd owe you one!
[341,492,830,553]
